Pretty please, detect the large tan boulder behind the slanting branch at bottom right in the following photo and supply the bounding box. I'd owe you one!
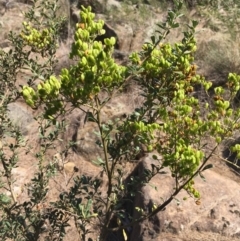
[131,156,240,241]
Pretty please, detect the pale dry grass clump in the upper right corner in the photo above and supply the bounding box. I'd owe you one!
[193,1,240,82]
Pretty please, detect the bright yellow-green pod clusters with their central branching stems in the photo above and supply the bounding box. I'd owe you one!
[18,4,240,240]
